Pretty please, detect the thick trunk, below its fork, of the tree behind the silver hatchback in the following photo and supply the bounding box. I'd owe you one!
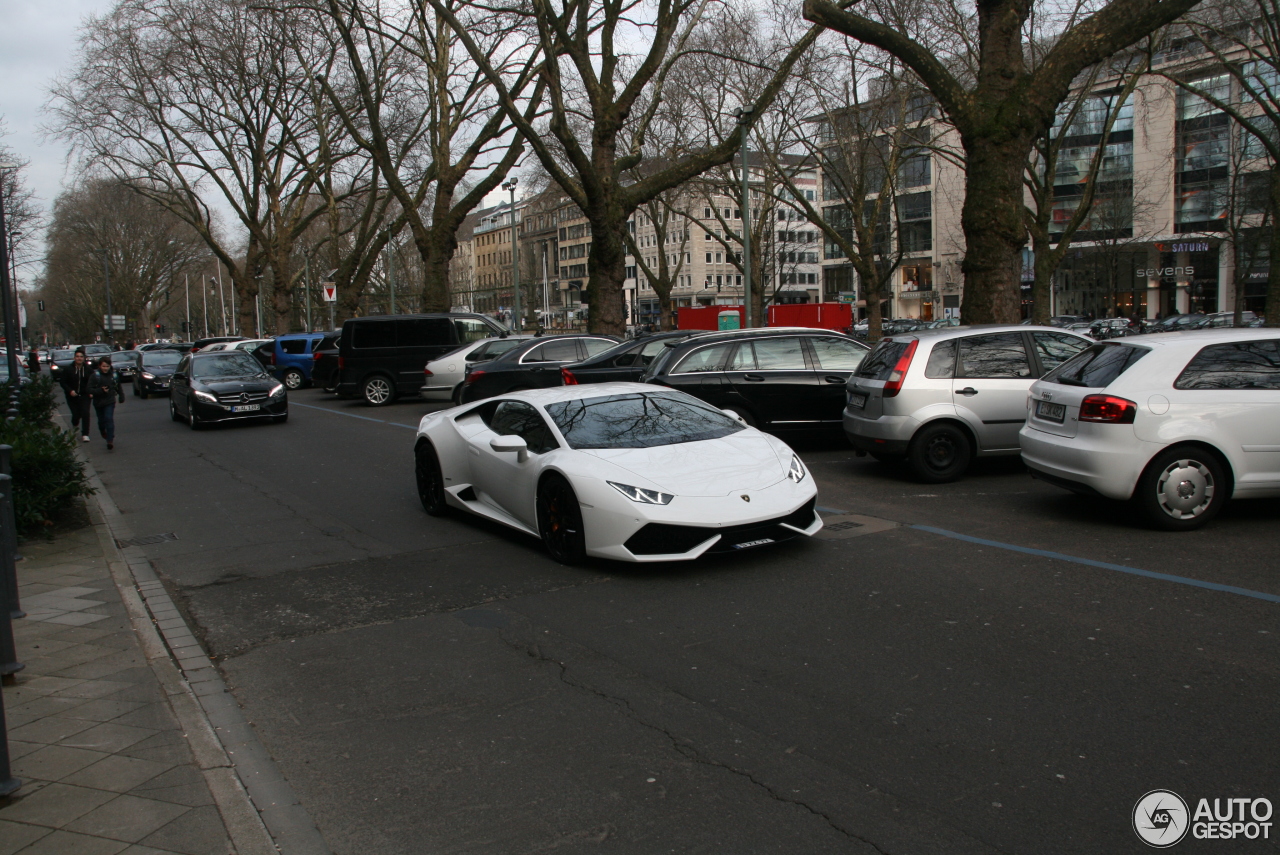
[960,134,1033,324]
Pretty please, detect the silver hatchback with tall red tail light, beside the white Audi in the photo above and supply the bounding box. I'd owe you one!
[844,325,1094,484]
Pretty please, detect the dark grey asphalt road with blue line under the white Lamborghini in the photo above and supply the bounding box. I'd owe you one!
[90,390,1280,855]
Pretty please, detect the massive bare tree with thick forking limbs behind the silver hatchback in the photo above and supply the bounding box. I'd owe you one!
[804,0,1197,323]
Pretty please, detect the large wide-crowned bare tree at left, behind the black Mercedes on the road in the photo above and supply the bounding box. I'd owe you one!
[51,0,378,332]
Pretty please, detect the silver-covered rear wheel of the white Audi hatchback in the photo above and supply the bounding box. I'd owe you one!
[1133,445,1228,531]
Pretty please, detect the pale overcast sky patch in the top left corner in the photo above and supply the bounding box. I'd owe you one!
[0,0,111,286]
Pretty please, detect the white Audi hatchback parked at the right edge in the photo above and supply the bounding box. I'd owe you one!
[1019,329,1280,531]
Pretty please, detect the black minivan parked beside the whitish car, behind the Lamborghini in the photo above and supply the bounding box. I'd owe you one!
[337,312,507,407]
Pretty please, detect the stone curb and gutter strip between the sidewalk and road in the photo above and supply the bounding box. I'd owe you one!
[77,430,333,855]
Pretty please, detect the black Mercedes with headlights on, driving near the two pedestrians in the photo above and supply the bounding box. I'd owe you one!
[169,351,289,430]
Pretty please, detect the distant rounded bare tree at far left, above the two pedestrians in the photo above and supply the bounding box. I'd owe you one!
[41,179,209,340]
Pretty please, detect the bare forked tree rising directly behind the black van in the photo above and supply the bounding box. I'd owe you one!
[324,0,541,311]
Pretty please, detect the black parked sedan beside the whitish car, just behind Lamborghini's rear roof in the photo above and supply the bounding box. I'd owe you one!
[461,333,618,403]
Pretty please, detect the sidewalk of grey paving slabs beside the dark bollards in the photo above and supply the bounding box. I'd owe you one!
[0,500,276,855]
